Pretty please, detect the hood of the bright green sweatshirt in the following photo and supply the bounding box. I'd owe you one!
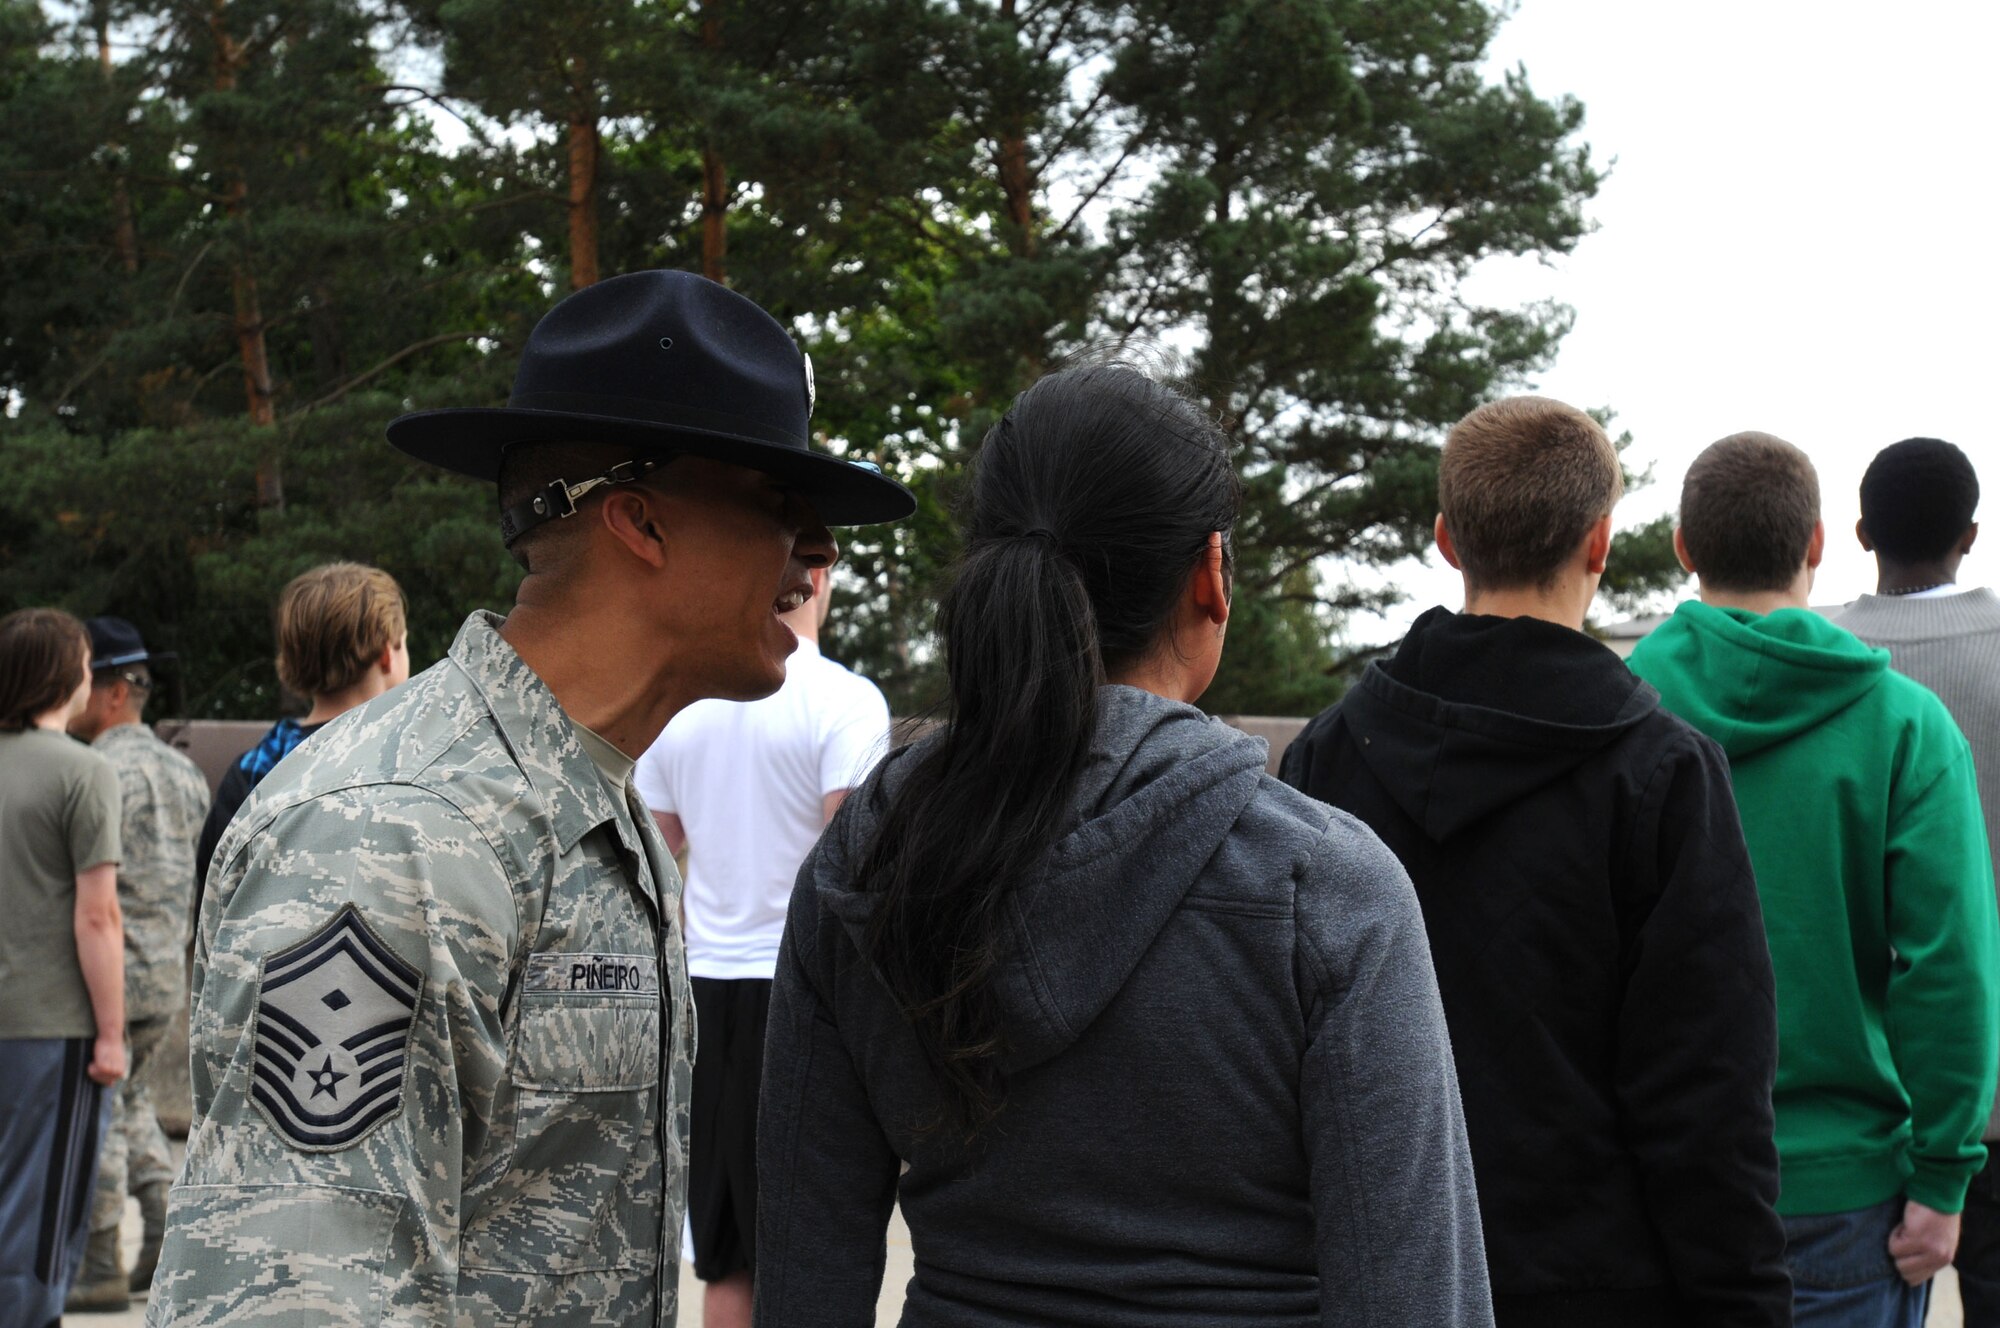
[1632,600,1888,758]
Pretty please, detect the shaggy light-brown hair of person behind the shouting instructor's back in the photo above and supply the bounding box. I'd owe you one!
[278,562,408,696]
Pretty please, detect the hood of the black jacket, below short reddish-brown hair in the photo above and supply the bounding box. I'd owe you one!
[1340,608,1660,840]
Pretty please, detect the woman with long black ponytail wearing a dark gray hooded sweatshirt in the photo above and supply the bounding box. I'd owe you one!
[754,366,1492,1328]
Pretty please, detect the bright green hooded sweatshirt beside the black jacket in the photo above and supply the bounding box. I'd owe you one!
[1632,602,2000,1216]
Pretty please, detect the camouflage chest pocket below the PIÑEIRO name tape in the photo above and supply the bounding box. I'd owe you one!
[460,992,666,1274]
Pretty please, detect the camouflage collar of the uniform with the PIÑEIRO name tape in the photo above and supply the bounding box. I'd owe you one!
[452,610,638,852]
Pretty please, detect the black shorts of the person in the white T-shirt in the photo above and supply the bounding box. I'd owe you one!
[688,978,770,1282]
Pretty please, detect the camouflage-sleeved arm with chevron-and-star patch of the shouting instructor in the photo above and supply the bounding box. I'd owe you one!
[148,784,528,1328]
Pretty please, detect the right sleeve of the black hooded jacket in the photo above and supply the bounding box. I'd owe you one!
[1614,738,1792,1326]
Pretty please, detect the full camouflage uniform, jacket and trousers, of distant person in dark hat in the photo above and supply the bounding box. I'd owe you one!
[90,724,208,1232]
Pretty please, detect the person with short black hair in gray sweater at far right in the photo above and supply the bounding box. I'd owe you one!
[1834,438,2000,1328]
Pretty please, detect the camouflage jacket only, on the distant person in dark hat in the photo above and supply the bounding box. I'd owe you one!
[90,724,208,1022]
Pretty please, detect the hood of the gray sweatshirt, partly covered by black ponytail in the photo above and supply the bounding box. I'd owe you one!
[812,686,1268,1074]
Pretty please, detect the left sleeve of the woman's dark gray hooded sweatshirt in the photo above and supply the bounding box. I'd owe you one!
[754,868,900,1328]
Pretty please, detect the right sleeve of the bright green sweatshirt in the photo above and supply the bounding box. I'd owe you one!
[1884,734,2000,1212]
